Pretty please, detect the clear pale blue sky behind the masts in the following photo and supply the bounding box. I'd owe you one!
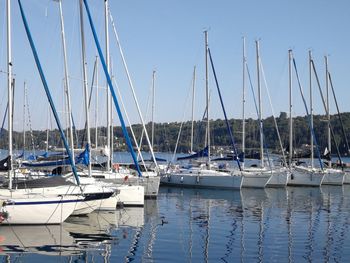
[0,0,350,130]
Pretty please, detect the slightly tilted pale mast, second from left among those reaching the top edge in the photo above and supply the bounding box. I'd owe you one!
[58,0,75,162]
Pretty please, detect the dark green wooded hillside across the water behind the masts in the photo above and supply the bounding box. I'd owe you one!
[0,112,350,155]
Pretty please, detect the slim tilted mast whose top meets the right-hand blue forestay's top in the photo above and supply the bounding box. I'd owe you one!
[79,0,91,176]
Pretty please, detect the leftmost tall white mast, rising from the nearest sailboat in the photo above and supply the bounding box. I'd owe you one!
[6,0,13,189]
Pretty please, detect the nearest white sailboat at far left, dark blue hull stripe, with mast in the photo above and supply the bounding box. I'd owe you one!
[0,0,84,225]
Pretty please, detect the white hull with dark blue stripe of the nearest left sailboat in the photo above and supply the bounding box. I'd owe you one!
[0,195,83,225]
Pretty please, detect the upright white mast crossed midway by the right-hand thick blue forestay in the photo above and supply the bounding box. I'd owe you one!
[105,0,112,171]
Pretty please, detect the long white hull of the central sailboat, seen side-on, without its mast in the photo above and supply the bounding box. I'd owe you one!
[160,169,242,189]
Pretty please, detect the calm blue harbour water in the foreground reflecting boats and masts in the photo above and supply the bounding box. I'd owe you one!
[0,186,350,262]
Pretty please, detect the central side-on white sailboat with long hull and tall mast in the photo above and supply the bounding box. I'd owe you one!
[160,31,242,189]
